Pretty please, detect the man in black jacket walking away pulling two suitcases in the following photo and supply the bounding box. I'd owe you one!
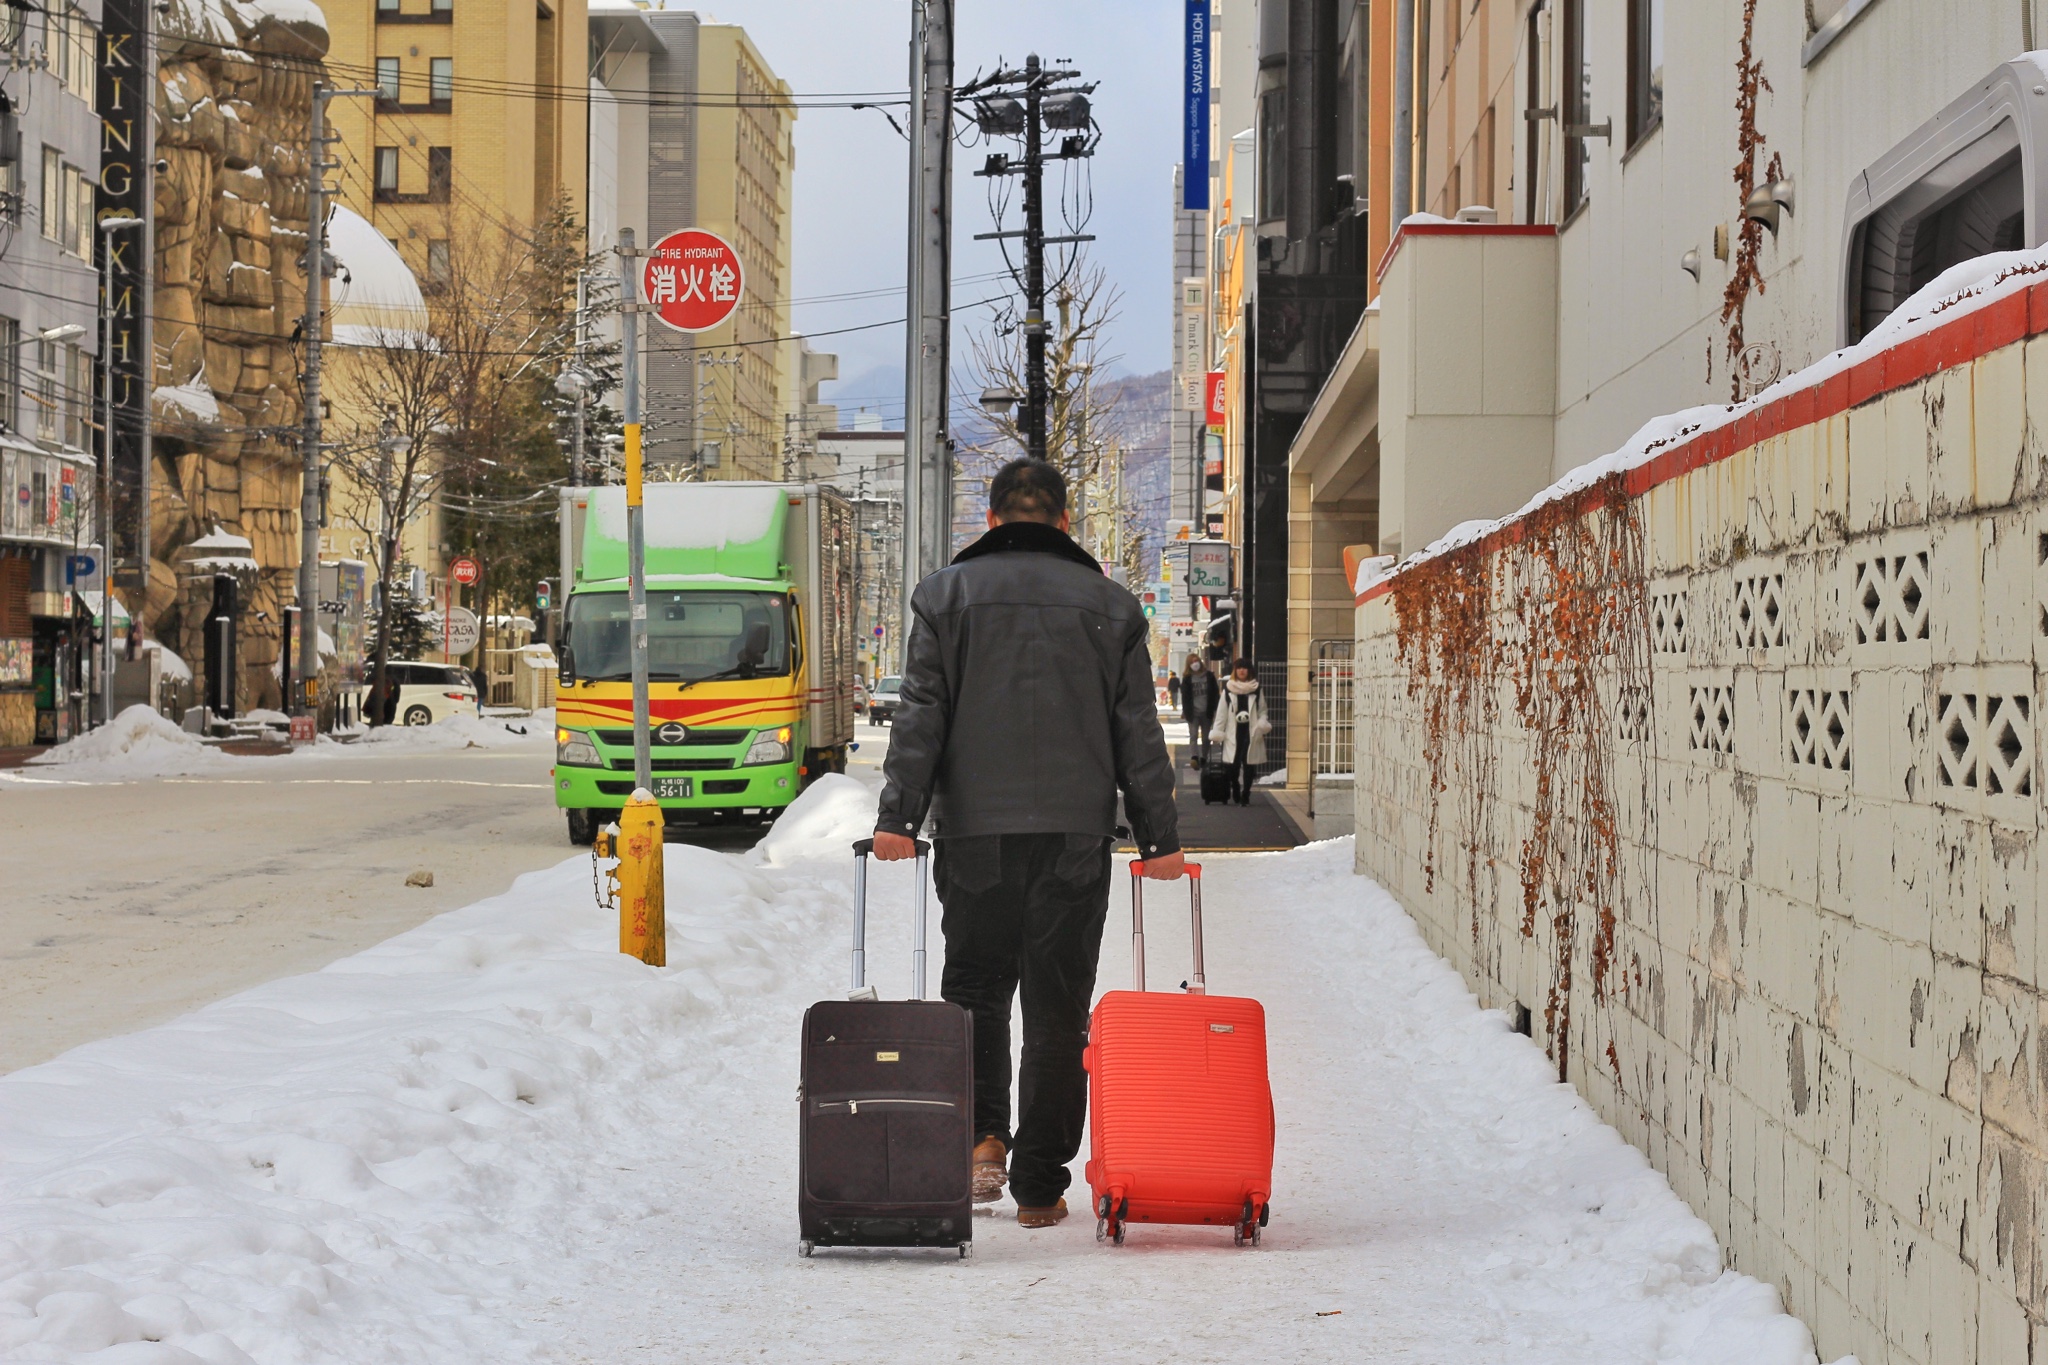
[874,460,1182,1228]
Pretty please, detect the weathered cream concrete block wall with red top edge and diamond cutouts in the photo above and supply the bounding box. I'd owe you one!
[1356,289,2048,1365]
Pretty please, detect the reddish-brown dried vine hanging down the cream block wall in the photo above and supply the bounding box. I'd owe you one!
[1393,475,1651,1078]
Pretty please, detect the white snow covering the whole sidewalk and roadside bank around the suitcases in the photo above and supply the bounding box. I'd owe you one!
[0,780,1835,1365]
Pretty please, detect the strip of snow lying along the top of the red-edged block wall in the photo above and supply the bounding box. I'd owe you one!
[1356,246,2048,591]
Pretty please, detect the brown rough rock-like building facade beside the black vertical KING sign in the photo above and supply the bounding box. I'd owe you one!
[143,0,328,706]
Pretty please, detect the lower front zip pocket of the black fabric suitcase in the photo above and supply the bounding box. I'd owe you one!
[805,1095,969,1203]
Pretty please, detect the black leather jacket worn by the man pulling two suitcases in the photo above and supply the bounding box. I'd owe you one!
[874,522,1180,857]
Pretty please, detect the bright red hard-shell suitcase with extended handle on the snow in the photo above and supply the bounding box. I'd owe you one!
[1083,862,1274,1246]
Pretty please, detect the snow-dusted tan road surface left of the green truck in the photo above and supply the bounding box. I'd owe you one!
[0,712,569,1072]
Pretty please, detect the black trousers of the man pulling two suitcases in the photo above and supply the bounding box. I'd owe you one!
[932,835,1110,1207]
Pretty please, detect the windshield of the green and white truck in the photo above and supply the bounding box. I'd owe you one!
[569,589,788,681]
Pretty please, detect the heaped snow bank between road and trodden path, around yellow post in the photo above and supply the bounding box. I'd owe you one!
[0,845,836,1365]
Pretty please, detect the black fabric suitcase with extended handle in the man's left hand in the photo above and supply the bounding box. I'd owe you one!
[797,839,975,1257]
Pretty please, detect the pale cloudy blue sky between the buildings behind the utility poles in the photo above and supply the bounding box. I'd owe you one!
[708,0,1182,426]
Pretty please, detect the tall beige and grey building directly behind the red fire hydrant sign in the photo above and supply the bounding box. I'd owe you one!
[590,0,794,479]
